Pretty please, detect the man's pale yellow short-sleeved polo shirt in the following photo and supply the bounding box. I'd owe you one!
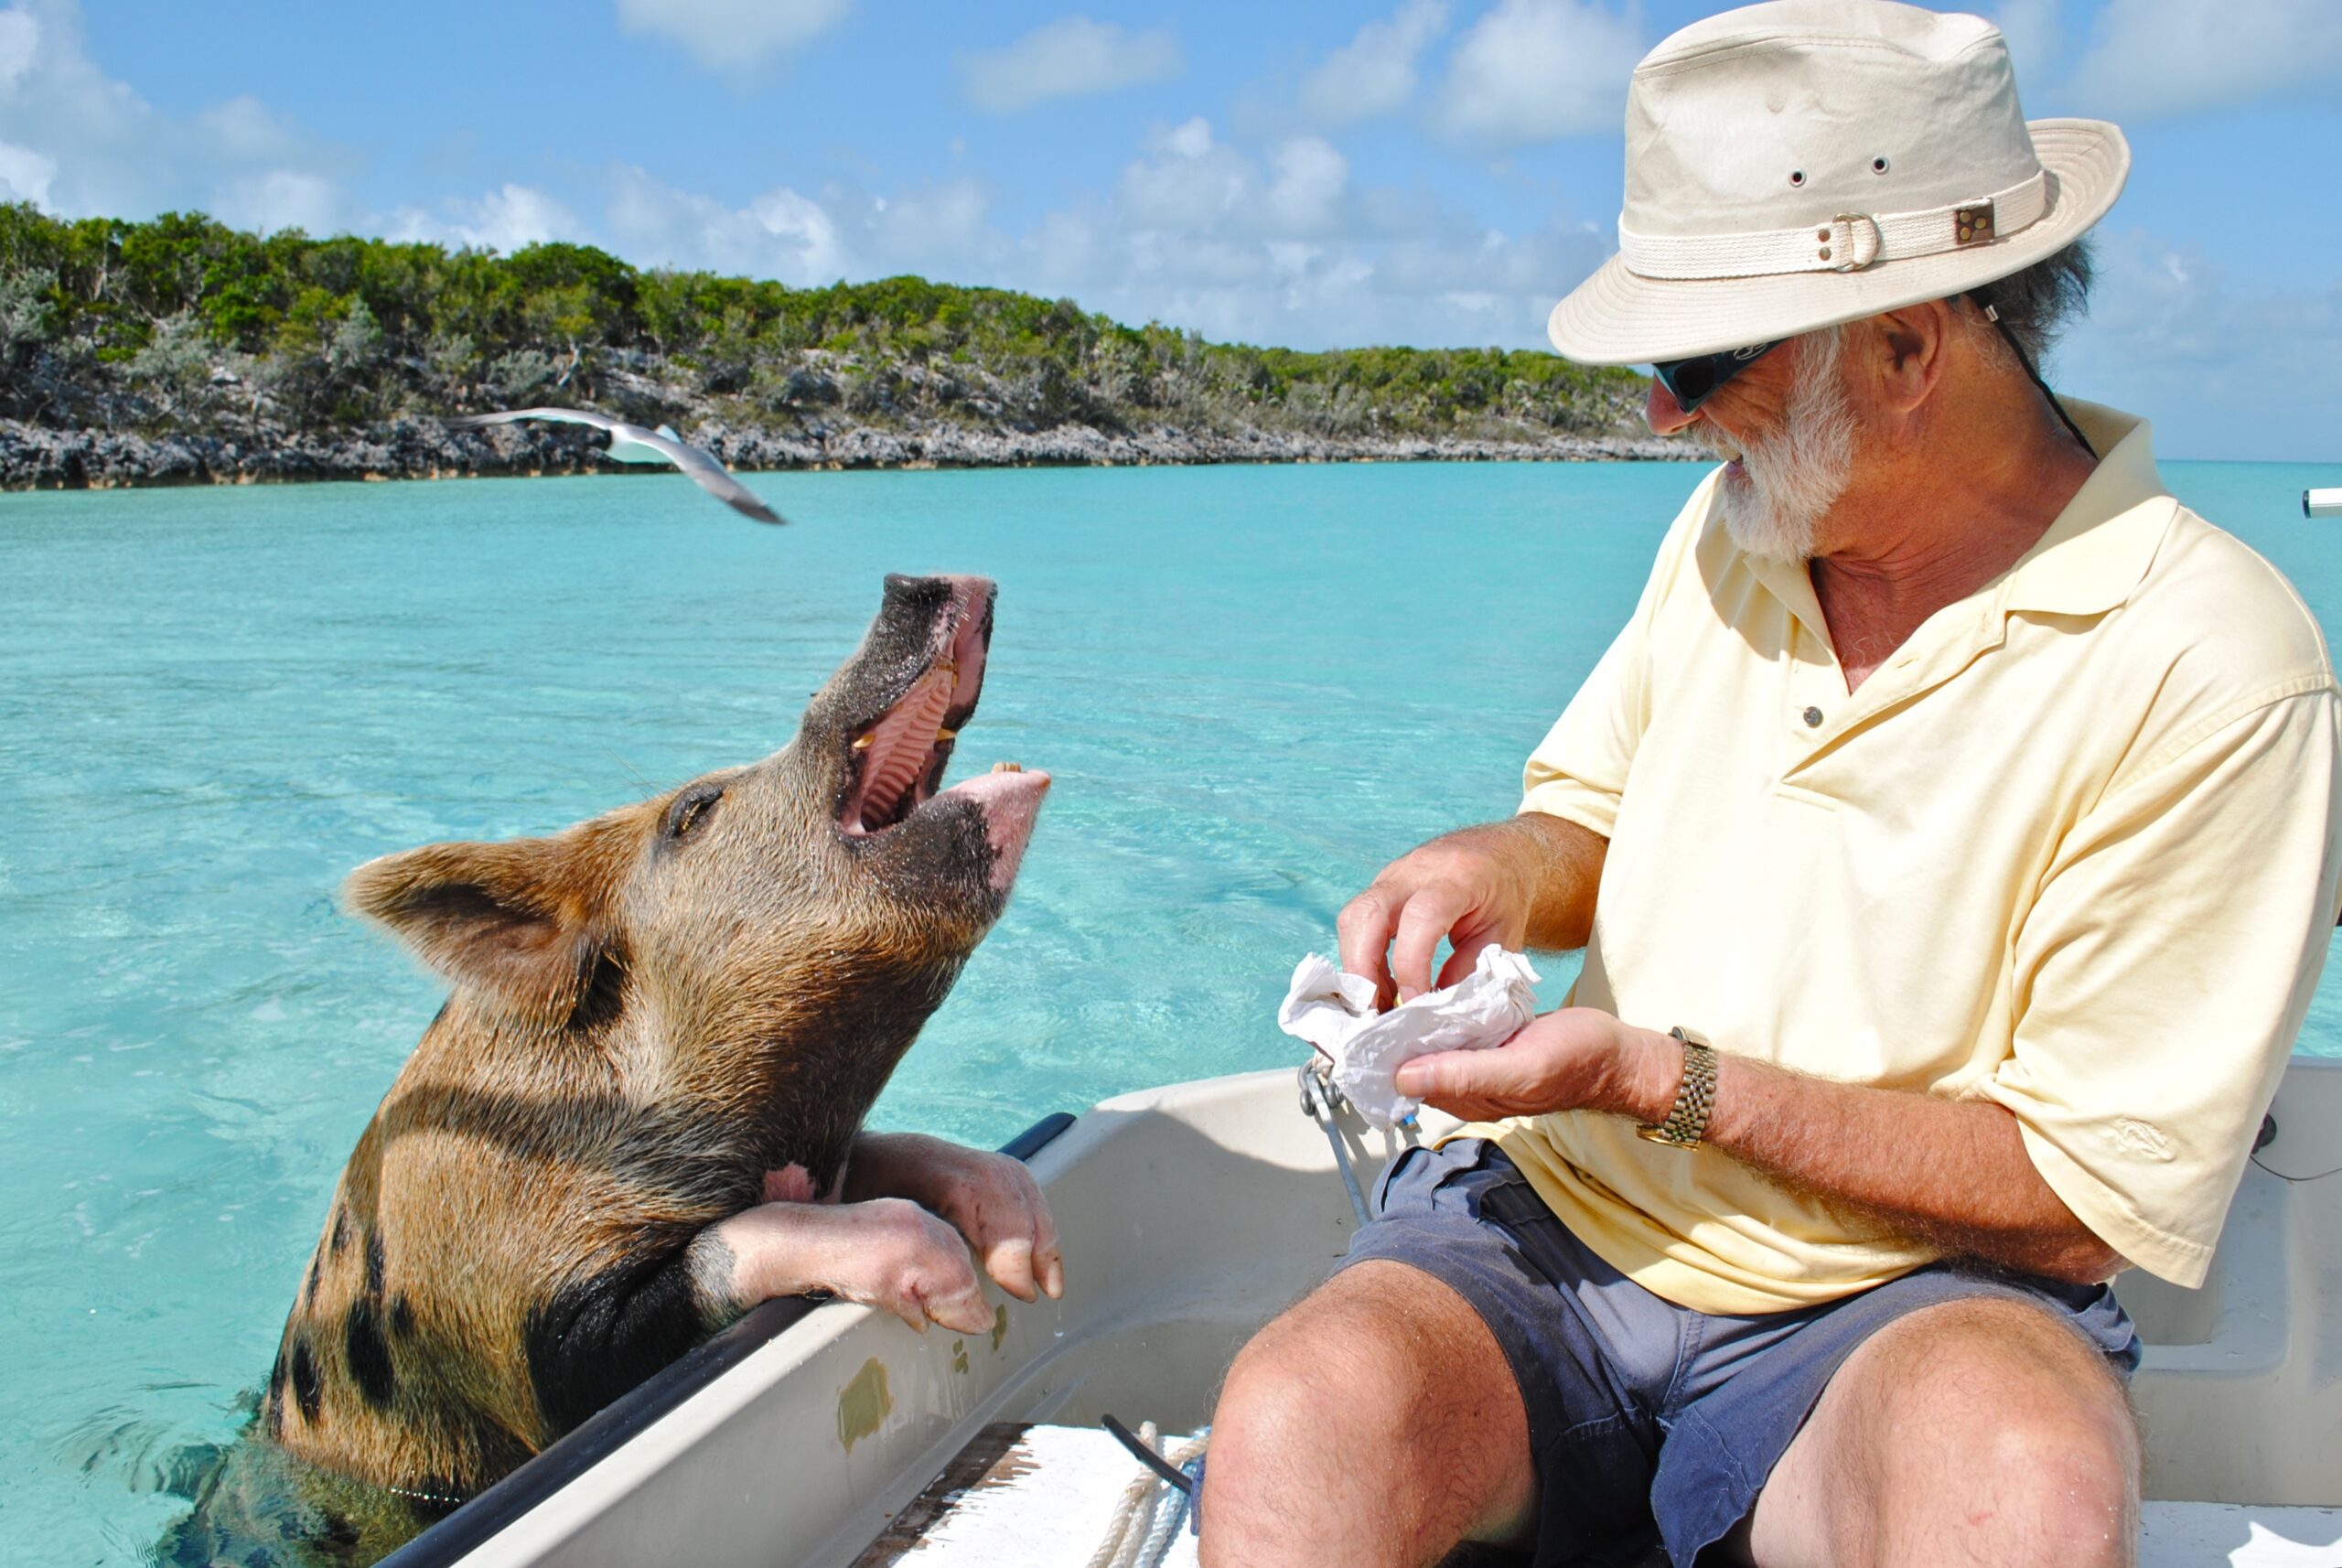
[1477,403,2342,1313]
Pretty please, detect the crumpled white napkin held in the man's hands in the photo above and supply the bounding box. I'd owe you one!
[1276,948,1536,1128]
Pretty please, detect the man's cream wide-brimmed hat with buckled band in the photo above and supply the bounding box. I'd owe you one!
[1548,0,2132,365]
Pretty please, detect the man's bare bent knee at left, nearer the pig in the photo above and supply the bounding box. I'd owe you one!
[1201,1259,1536,1568]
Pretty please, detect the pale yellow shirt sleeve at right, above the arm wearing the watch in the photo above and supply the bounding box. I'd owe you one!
[1979,676,2342,1287]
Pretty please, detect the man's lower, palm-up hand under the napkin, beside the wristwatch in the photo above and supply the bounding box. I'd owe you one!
[1396,1006,1681,1121]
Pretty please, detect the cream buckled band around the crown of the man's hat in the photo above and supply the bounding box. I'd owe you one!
[1618,168,2049,278]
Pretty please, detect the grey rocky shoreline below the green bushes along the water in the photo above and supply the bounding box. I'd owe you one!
[0,419,1703,489]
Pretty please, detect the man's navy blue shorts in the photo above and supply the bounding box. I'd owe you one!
[1342,1137,2138,1568]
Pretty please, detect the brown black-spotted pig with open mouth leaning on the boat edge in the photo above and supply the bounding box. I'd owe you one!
[164,575,1063,1561]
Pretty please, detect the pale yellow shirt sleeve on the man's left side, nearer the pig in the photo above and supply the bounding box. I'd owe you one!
[1520,479,1714,838]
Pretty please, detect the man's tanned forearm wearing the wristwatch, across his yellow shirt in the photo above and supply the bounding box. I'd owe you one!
[1605,1030,2122,1283]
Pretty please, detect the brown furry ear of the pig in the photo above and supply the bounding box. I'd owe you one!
[342,817,639,1023]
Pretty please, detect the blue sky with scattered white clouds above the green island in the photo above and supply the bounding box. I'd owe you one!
[0,0,2342,461]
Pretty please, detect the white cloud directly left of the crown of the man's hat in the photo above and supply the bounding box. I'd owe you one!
[1438,0,1644,147]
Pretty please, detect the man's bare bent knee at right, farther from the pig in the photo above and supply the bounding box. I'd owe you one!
[1735,1299,2138,1568]
